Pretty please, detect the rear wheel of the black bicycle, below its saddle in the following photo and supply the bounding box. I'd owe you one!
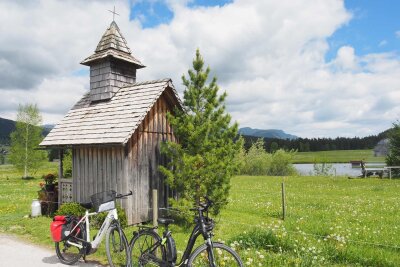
[129,230,167,267]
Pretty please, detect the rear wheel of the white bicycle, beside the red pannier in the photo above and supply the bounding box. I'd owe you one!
[55,224,86,265]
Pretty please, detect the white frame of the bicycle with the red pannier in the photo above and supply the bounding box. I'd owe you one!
[67,209,118,249]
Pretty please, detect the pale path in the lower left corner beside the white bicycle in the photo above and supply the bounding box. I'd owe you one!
[0,235,101,267]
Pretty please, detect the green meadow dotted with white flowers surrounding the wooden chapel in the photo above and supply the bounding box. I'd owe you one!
[0,164,400,266]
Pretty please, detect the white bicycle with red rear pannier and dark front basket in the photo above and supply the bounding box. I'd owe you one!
[50,191,132,267]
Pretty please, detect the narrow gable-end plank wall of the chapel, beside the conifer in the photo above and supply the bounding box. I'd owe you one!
[127,91,175,223]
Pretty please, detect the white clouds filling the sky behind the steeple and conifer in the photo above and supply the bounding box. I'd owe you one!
[0,0,400,137]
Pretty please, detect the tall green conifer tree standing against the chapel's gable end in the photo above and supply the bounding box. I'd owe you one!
[160,50,241,213]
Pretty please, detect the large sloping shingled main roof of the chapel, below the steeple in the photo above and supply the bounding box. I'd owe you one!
[40,79,181,146]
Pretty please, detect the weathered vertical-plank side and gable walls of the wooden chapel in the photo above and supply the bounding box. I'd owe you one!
[72,90,176,224]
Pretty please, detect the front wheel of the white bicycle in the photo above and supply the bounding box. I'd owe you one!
[106,225,129,267]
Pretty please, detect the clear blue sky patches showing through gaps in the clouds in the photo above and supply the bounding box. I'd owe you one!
[130,0,400,61]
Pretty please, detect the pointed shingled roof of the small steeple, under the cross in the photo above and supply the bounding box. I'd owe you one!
[81,21,145,69]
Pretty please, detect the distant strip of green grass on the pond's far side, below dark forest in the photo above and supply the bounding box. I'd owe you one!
[293,149,385,163]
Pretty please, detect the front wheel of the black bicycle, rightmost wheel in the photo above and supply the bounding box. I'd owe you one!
[187,242,243,267]
